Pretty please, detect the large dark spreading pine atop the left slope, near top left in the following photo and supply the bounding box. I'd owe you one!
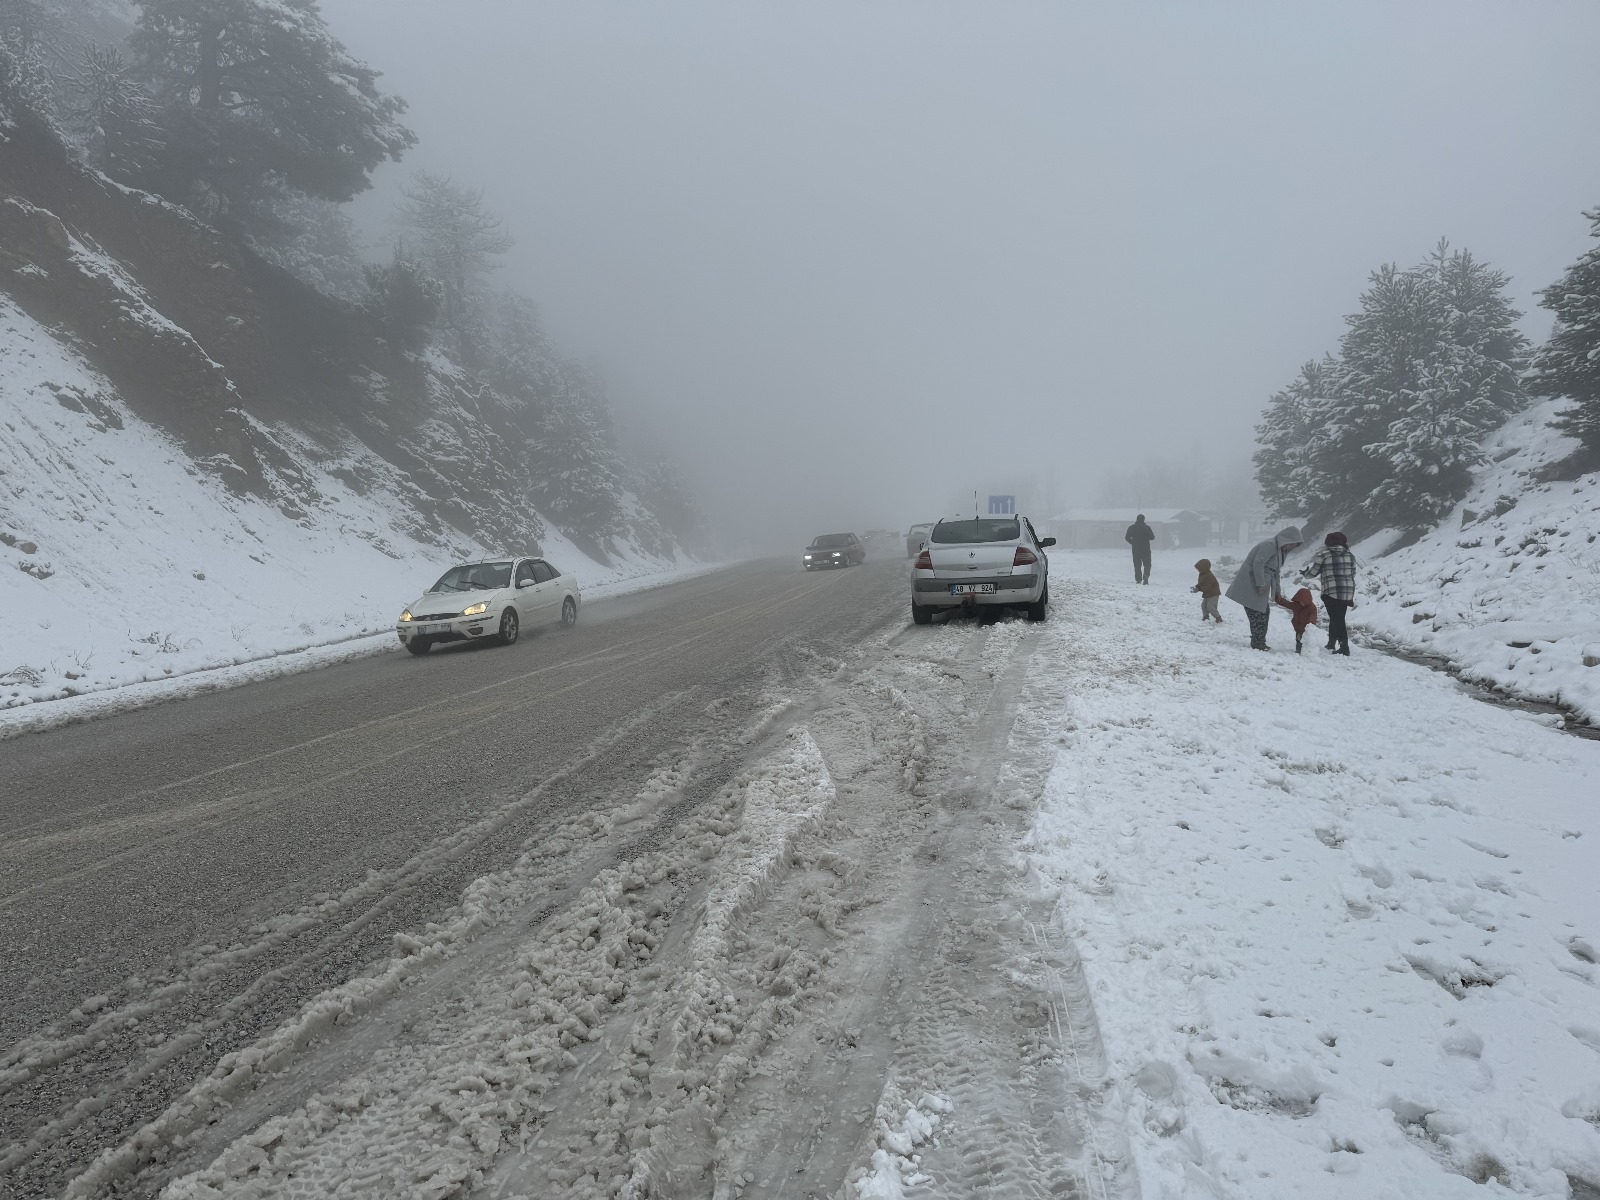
[130,0,416,222]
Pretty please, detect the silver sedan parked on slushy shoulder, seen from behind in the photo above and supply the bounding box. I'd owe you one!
[910,517,1056,626]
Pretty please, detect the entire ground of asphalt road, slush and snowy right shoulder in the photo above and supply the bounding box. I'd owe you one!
[0,554,1600,1200]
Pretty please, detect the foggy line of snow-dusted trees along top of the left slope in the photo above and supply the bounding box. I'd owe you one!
[0,0,701,546]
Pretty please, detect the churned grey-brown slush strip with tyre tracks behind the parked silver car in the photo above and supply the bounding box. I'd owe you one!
[56,588,1117,1200]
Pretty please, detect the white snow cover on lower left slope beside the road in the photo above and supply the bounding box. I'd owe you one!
[0,294,697,709]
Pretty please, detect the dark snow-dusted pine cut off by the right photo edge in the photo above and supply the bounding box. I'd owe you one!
[1528,208,1600,453]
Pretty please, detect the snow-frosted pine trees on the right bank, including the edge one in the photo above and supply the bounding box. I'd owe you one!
[1254,210,1600,533]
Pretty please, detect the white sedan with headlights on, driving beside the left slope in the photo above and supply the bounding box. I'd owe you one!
[395,555,582,654]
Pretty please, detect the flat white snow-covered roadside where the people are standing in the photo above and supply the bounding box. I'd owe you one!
[1027,552,1600,1200]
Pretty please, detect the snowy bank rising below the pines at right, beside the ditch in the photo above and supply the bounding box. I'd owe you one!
[1352,402,1600,723]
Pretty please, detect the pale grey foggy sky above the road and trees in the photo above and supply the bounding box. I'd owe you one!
[323,0,1600,536]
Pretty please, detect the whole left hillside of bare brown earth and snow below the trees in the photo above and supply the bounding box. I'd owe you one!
[0,108,694,706]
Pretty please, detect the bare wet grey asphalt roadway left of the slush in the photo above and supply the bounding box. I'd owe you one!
[0,560,906,1195]
